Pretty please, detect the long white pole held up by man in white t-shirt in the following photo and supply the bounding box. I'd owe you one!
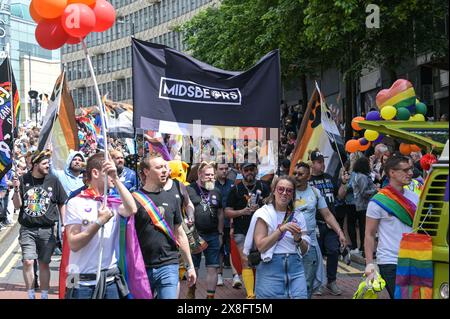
[81,39,109,285]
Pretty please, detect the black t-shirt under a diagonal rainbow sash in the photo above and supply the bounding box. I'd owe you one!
[135,189,181,268]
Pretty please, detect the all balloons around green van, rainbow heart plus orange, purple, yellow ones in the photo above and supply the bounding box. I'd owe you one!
[345,79,427,155]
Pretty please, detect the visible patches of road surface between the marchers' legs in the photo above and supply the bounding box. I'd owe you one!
[0,215,388,299]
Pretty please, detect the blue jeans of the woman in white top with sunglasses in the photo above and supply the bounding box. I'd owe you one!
[255,254,307,299]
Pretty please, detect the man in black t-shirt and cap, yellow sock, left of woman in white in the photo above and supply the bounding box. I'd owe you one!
[225,161,270,299]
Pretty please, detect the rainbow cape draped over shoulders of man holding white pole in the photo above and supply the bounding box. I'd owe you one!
[59,187,153,299]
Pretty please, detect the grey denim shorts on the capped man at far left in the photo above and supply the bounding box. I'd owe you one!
[19,226,56,264]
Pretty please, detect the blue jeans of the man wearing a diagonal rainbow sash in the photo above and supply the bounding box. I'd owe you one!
[147,264,179,299]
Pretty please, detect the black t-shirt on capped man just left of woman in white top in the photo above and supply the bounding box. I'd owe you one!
[227,181,270,235]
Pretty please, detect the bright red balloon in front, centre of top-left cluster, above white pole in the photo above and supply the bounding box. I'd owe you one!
[61,3,95,38]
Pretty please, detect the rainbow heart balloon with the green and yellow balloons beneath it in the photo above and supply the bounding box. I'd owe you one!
[376,79,427,121]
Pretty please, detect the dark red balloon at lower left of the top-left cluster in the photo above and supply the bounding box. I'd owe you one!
[34,19,69,50]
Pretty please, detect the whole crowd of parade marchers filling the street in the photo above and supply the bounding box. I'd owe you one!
[0,114,438,299]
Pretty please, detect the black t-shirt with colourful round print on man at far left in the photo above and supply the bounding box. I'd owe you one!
[19,172,67,228]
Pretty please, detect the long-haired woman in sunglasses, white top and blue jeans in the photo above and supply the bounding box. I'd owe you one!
[244,176,310,299]
